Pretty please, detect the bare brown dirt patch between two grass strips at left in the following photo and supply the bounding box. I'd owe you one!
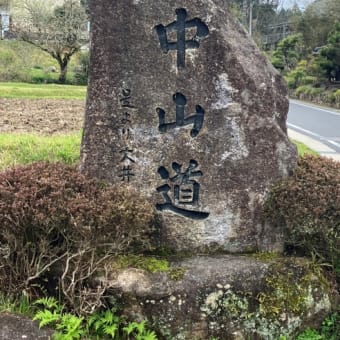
[0,98,85,135]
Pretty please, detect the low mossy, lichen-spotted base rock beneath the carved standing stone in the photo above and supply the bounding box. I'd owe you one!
[105,254,334,340]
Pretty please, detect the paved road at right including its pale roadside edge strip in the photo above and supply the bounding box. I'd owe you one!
[287,100,340,160]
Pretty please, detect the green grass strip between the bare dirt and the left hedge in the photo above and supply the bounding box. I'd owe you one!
[0,133,81,170]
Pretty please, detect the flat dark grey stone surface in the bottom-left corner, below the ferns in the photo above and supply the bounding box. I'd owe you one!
[0,313,53,340]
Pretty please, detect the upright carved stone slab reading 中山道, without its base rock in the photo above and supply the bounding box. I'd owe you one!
[81,0,296,252]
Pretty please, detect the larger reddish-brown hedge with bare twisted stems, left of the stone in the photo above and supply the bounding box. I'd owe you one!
[0,163,153,308]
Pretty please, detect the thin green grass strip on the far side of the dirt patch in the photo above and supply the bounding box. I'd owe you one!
[0,83,86,99]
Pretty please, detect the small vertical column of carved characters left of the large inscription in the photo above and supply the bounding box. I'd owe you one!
[119,87,136,182]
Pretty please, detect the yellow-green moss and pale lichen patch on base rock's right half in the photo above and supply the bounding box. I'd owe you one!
[201,254,329,340]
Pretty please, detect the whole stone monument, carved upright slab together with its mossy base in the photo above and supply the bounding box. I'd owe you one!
[81,0,332,340]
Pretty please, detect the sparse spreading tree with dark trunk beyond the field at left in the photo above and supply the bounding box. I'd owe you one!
[13,0,88,84]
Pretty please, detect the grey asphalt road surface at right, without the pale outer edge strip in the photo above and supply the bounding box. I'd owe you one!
[287,100,340,153]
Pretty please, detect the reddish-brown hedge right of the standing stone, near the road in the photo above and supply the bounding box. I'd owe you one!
[265,155,340,269]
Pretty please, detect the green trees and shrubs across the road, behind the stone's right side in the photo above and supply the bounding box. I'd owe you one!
[229,0,340,108]
